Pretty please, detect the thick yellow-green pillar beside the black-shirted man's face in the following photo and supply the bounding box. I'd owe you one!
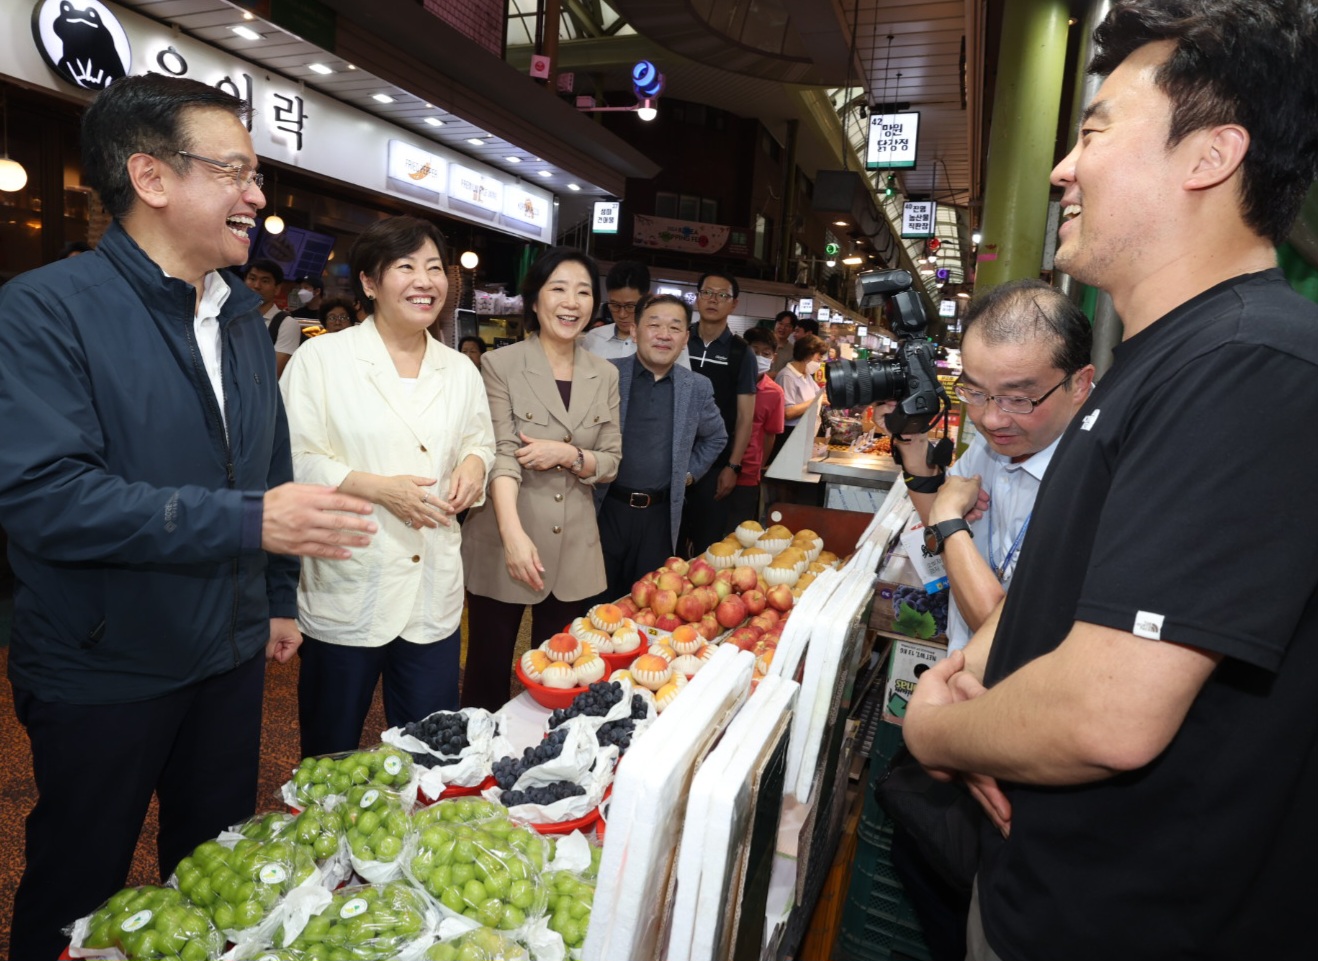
[975,0,1069,290]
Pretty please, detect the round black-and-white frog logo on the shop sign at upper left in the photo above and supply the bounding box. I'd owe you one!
[32,0,133,90]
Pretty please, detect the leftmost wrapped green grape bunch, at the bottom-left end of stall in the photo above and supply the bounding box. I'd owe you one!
[83,886,224,961]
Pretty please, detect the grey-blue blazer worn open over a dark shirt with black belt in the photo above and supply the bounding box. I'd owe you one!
[594,357,728,550]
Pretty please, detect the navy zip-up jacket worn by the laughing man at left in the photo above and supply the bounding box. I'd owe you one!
[0,223,298,704]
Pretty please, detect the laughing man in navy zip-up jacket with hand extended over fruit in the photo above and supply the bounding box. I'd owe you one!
[0,75,374,960]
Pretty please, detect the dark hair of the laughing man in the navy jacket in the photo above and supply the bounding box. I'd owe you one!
[82,74,248,220]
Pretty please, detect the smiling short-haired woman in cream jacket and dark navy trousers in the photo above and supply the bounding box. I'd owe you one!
[281,218,494,755]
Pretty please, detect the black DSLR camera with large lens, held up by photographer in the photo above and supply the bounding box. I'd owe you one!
[824,270,952,437]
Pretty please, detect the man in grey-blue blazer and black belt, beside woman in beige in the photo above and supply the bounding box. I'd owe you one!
[596,294,728,600]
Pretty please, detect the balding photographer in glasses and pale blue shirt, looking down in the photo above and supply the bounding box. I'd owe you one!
[898,281,1094,650]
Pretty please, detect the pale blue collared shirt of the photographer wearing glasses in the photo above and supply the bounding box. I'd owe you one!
[948,435,1061,651]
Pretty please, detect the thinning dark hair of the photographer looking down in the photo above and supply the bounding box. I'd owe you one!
[961,279,1094,376]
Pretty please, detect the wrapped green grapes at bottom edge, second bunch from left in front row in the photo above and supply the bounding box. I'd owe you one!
[274,881,428,961]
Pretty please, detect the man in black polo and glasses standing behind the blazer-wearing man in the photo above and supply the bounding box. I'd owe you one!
[681,272,759,555]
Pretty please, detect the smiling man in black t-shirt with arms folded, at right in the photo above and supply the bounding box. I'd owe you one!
[905,0,1318,961]
